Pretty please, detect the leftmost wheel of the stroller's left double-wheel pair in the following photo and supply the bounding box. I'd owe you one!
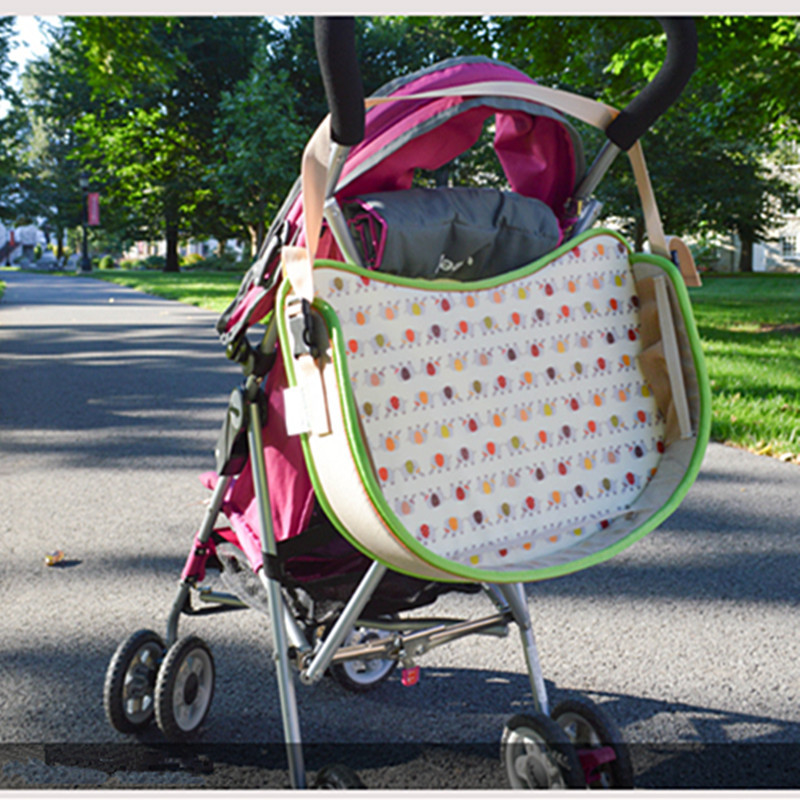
[103,630,165,733]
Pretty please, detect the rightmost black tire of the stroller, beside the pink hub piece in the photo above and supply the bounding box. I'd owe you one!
[551,698,633,789]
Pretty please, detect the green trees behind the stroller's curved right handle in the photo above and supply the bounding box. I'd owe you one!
[406,16,800,269]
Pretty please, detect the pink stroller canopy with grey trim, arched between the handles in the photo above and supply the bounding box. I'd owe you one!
[337,57,585,219]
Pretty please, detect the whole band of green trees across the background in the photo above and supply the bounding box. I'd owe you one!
[0,16,800,269]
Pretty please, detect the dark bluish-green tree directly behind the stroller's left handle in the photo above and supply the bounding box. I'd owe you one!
[209,17,466,248]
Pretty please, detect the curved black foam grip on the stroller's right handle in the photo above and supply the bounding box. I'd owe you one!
[606,17,697,150]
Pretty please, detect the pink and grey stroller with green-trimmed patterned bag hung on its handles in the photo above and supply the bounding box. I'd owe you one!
[104,18,710,788]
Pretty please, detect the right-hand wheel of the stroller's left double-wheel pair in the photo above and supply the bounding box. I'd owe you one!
[155,636,215,742]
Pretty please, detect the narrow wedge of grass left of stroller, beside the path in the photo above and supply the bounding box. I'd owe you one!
[86,269,242,313]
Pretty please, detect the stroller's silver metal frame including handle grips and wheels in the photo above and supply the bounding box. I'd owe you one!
[104,15,696,789]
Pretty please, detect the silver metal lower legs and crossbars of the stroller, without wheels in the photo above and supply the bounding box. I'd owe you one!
[165,320,552,789]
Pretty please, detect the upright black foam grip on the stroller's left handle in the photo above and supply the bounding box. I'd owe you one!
[314,17,364,146]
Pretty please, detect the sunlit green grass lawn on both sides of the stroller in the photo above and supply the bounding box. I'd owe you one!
[87,270,800,462]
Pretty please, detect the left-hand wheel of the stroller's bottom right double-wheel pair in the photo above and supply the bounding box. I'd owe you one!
[500,713,586,789]
